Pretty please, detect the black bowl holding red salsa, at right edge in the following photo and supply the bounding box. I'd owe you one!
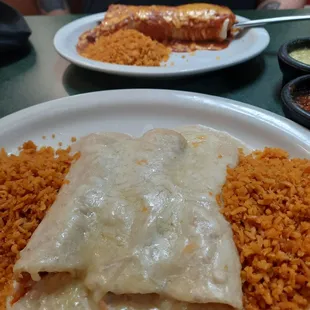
[281,75,310,129]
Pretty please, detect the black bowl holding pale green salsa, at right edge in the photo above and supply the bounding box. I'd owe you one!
[278,38,310,83]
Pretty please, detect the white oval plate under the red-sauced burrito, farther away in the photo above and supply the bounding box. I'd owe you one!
[54,13,270,77]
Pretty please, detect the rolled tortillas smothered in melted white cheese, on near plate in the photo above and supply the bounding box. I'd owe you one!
[10,127,243,310]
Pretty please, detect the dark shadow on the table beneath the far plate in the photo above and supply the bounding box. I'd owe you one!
[63,56,265,96]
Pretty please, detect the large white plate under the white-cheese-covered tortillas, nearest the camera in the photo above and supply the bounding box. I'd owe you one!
[0,89,310,158]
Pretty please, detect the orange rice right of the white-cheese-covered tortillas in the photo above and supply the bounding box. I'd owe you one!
[218,148,310,310]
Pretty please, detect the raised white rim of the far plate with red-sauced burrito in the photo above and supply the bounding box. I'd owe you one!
[53,12,270,77]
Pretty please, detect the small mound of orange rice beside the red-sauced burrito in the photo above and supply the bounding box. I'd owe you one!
[80,29,171,66]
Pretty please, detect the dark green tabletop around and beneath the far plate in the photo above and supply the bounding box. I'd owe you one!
[0,10,310,117]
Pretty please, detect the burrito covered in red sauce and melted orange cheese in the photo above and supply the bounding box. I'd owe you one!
[78,3,236,50]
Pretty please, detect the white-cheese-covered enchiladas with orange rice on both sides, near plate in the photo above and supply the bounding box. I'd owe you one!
[0,126,310,310]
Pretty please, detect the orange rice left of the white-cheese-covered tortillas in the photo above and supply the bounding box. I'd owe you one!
[0,141,79,310]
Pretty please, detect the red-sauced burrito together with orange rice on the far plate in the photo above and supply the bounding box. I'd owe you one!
[77,3,236,64]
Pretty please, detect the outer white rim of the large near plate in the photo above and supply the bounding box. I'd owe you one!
[0,88,310,148]
